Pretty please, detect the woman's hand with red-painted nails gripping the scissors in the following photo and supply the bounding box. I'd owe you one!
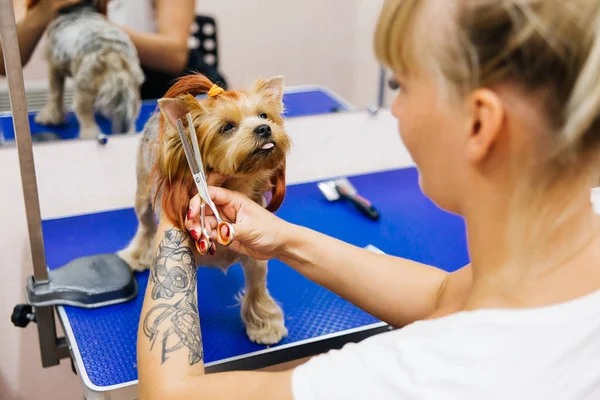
[186,178,288,260]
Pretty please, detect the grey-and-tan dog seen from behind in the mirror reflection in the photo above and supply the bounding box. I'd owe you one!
[27,0,145,139]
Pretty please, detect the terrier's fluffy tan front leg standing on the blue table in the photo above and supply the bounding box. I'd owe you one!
[241,258,288,344]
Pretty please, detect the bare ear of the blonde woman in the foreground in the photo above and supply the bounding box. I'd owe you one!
[466,89,504,162]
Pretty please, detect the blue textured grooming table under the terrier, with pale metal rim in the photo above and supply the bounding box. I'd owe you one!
[43,168,469,400]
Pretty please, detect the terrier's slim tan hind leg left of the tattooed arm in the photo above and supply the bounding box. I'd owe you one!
[117,147,156,271]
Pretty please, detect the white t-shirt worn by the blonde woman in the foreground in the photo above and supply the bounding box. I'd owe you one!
[292,291,600,400]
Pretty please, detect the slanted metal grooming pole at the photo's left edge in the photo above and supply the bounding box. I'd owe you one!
[0,0,70,368]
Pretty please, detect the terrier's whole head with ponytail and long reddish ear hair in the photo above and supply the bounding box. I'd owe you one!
[152,74,290,229]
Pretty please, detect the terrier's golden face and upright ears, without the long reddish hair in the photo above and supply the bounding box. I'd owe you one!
[159,77,290,178]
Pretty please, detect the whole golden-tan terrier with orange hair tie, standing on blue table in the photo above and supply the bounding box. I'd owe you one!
[118,74,290,344]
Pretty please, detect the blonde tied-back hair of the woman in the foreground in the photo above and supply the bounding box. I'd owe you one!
[375,0,600,264]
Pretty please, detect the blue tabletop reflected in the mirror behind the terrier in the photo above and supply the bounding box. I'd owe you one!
[0,86,352,141]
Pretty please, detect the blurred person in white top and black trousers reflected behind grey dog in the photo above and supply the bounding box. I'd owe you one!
[0,0,226,99]
